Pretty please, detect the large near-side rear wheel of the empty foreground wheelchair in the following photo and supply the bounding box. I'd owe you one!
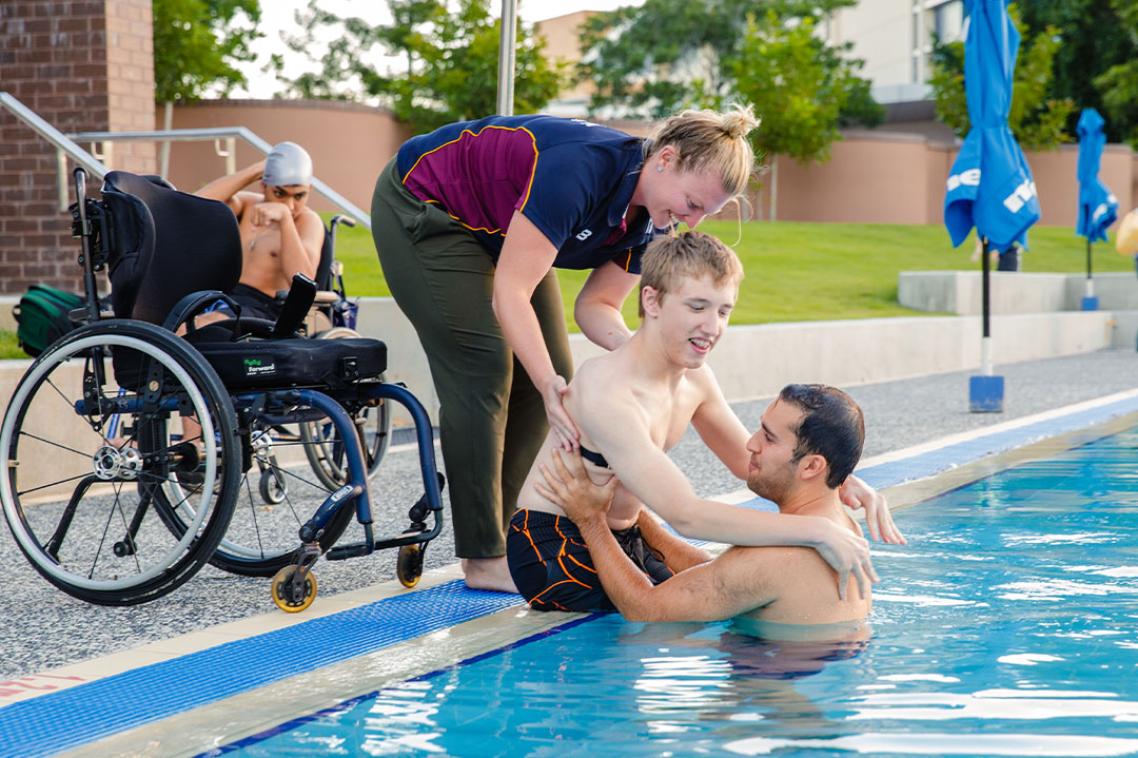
[0,320,240,605]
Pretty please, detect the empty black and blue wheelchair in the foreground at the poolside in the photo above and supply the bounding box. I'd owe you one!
[0,168,444,612]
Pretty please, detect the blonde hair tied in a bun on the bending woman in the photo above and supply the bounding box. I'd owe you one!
[648,105,759,197]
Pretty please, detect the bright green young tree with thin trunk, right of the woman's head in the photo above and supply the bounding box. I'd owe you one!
[731,11,880,221]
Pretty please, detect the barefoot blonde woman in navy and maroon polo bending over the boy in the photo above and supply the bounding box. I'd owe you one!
[372,108,796,592]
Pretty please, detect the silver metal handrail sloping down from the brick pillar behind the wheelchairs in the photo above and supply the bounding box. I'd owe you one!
[0,91,371,229]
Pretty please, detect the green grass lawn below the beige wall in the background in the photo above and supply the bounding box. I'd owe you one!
[337,213,1133,330]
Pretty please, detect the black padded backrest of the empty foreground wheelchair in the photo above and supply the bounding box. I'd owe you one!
[101,171,241,323]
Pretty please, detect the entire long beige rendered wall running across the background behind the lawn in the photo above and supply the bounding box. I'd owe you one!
[160,100,1138,226]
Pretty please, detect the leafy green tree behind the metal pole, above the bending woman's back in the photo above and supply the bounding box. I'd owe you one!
[278,0,562,131]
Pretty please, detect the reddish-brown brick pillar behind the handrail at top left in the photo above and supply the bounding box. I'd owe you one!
[0,0,155,294]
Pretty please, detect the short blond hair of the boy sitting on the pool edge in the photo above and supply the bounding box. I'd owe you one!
[640,231,743,318]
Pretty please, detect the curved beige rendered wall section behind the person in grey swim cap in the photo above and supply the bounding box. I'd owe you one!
[157,100,410,213]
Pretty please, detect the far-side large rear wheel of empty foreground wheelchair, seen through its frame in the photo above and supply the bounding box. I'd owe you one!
[156,400,356,577]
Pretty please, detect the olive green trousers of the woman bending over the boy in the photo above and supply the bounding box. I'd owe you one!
[371,160,572,558]
